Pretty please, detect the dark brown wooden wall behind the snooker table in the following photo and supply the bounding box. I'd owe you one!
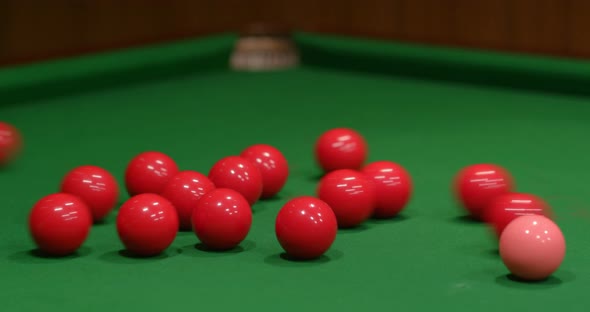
[0,0,590,65]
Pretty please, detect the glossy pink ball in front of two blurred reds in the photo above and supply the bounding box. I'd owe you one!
[499,215,566,281]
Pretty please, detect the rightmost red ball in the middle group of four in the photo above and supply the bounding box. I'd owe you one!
[362,161,412,218]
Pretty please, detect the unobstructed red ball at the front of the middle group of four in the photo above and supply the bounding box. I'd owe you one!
[275,196,338,260]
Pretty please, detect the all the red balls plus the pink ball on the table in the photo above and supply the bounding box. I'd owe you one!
[0,122,565,280]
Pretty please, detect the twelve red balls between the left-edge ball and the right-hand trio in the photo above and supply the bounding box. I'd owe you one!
[23,123,412,259]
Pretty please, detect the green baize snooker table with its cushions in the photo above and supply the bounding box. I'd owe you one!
[0,33,590,311]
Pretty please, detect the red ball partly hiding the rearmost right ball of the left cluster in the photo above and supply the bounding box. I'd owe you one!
[208,156,263,206]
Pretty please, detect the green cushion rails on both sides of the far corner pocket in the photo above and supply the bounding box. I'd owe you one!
[0,32,590,105]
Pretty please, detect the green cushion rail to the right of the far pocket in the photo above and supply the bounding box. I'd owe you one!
[295,33,590,96]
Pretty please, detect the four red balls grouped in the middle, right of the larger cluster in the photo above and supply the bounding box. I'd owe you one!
[276,128,412,260]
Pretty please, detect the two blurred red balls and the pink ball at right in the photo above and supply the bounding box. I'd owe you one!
[454,164,565,280]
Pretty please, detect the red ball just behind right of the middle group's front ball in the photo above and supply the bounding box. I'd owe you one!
[317,169,377,228]
